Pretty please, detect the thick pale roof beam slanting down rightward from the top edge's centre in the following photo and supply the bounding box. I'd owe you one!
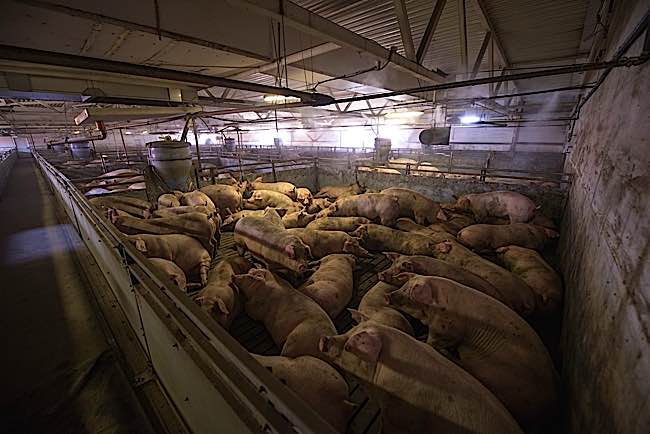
[223,0,444,83]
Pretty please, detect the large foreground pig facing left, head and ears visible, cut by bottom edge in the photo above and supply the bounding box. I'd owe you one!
[319,320,522,434]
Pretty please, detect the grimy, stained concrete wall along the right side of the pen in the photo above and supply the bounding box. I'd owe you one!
[561,1,650,434]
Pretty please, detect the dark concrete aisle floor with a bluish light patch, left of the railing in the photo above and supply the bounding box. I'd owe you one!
[0,157,150,433]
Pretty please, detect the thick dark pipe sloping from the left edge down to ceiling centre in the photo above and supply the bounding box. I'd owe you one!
[0,45,333,105]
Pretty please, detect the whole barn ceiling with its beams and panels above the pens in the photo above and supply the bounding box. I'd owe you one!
[0,0,600,134]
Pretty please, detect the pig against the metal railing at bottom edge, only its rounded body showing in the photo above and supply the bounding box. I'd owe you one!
[252,354,354,434]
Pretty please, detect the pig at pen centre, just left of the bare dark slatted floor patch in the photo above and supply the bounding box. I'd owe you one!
[298,254,356,318]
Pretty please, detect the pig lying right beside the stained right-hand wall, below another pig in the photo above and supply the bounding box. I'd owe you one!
[497,246,563,316]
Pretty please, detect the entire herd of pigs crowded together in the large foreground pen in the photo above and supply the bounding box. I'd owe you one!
[91,178,563,433]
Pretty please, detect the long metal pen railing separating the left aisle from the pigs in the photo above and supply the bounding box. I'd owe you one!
[34,153,334,433]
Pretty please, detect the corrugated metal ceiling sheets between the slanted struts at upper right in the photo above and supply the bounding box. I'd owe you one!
[295,0,587,74]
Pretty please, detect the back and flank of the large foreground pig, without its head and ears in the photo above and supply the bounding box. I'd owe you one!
[375,327,522,434]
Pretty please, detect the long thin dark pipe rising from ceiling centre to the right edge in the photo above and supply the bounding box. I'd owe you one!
[334,55,650,104]
